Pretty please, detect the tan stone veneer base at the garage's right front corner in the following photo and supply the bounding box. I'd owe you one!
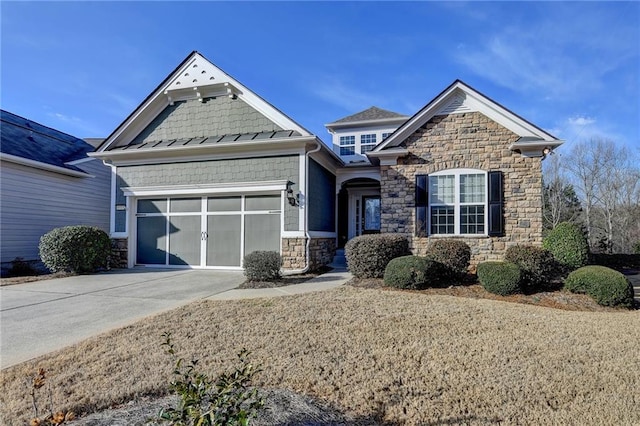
[282,238,336,271]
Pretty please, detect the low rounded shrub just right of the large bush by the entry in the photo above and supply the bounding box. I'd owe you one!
[384,256,445,290]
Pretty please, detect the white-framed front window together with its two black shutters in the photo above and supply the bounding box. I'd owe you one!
[416,169,502,236]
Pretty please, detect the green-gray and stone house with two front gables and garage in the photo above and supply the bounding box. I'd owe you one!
[90,52,561,271]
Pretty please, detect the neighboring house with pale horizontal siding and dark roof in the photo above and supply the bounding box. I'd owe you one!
[0,110,111,270]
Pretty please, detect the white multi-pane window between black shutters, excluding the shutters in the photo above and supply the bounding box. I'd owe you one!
[427,169,487,235]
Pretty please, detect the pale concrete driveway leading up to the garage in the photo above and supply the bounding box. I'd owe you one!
[0,268,244,368]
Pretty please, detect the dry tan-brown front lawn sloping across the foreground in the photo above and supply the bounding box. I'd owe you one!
[0,287,640,425]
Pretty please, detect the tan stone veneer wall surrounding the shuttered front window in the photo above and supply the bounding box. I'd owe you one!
[380,112,542,266]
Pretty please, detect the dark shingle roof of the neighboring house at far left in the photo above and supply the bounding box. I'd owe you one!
[0,110,94,172]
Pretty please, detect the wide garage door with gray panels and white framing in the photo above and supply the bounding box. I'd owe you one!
[136,195,282,268]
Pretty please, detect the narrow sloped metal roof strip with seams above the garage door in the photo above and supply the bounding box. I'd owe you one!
[110,130,300,151]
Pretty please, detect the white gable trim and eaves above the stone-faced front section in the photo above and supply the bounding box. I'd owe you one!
[369,80,562,155]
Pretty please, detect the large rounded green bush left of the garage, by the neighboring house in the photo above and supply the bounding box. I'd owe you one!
[38,225,111,274]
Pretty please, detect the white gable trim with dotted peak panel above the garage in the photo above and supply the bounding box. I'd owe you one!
[97,51,311,152]
